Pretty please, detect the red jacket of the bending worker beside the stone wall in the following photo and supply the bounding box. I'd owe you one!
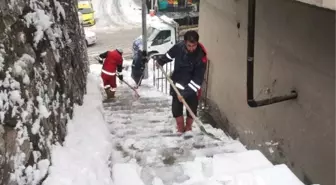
[99,50,123,76]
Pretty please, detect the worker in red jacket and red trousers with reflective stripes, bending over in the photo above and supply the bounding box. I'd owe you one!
[99,49,123,99]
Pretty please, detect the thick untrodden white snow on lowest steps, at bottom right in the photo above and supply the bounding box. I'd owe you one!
[173,150,304,185]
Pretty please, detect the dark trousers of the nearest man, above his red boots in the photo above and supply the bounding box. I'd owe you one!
[172,94,198,118]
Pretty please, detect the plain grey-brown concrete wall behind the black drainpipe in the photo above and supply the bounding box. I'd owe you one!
[199,0,336,185]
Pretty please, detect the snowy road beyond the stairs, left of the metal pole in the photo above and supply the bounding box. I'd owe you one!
[85,0,141,61]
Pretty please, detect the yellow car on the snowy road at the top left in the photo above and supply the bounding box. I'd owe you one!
[78,1,96,26]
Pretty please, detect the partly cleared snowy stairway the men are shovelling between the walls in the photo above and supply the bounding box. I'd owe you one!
[99,73,303,185]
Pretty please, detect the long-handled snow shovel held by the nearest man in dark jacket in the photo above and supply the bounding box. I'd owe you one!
[157,64,221,141]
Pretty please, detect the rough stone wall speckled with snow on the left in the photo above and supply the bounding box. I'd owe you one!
[0,0,88,185]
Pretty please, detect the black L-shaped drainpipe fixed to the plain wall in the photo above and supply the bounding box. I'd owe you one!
[247,0,298,107]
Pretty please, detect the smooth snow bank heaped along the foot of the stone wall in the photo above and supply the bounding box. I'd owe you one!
[43,73,112,185]
